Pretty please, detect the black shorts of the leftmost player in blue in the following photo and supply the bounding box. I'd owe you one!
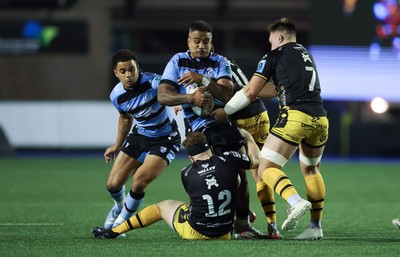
[121,124,181,165]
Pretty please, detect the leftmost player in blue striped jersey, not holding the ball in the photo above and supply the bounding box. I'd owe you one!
[104,49,181,228]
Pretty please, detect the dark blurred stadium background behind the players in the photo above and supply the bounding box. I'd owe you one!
[0,0,400,158]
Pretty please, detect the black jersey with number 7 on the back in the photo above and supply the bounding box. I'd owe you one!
[254,42,326,116]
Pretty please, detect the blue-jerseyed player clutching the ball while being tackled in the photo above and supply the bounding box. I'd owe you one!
[158,20,266,239]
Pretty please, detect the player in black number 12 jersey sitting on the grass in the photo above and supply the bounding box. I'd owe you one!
[92,130,259,240]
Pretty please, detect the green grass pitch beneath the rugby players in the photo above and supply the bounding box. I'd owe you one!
[0,157,400,257]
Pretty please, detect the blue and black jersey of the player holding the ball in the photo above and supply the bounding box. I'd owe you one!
[160,51,232,131]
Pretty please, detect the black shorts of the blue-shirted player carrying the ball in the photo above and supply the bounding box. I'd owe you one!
[199,121,244,154]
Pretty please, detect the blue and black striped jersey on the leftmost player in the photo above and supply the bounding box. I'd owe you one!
[110,72,176,137]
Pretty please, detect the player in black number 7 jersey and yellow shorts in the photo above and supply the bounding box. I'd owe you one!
[211,18,329,240]
